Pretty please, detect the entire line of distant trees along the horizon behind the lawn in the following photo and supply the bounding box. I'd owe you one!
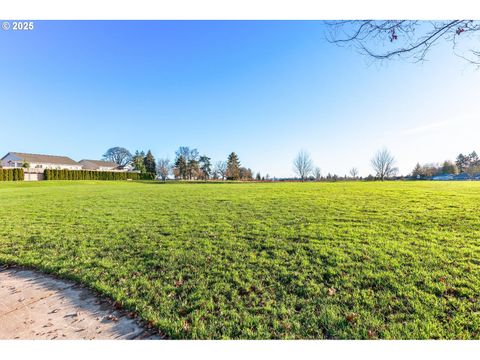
[103,146,480,181]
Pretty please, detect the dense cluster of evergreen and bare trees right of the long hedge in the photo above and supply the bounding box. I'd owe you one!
[103,146,260,181]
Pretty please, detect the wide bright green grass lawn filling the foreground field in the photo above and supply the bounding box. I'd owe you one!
[0,181,480,339]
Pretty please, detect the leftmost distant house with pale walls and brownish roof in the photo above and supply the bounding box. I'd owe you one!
[1,152,82,171]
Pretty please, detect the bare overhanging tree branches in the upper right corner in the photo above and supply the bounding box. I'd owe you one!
[326,20,480,66]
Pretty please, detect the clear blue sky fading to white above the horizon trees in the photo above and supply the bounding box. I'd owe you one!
[0,21,480,177]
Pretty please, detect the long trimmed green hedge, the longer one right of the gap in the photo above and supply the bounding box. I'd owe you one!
[43,169,155,180]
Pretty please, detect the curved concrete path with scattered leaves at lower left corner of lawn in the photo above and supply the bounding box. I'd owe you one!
[0,267,160,340]
